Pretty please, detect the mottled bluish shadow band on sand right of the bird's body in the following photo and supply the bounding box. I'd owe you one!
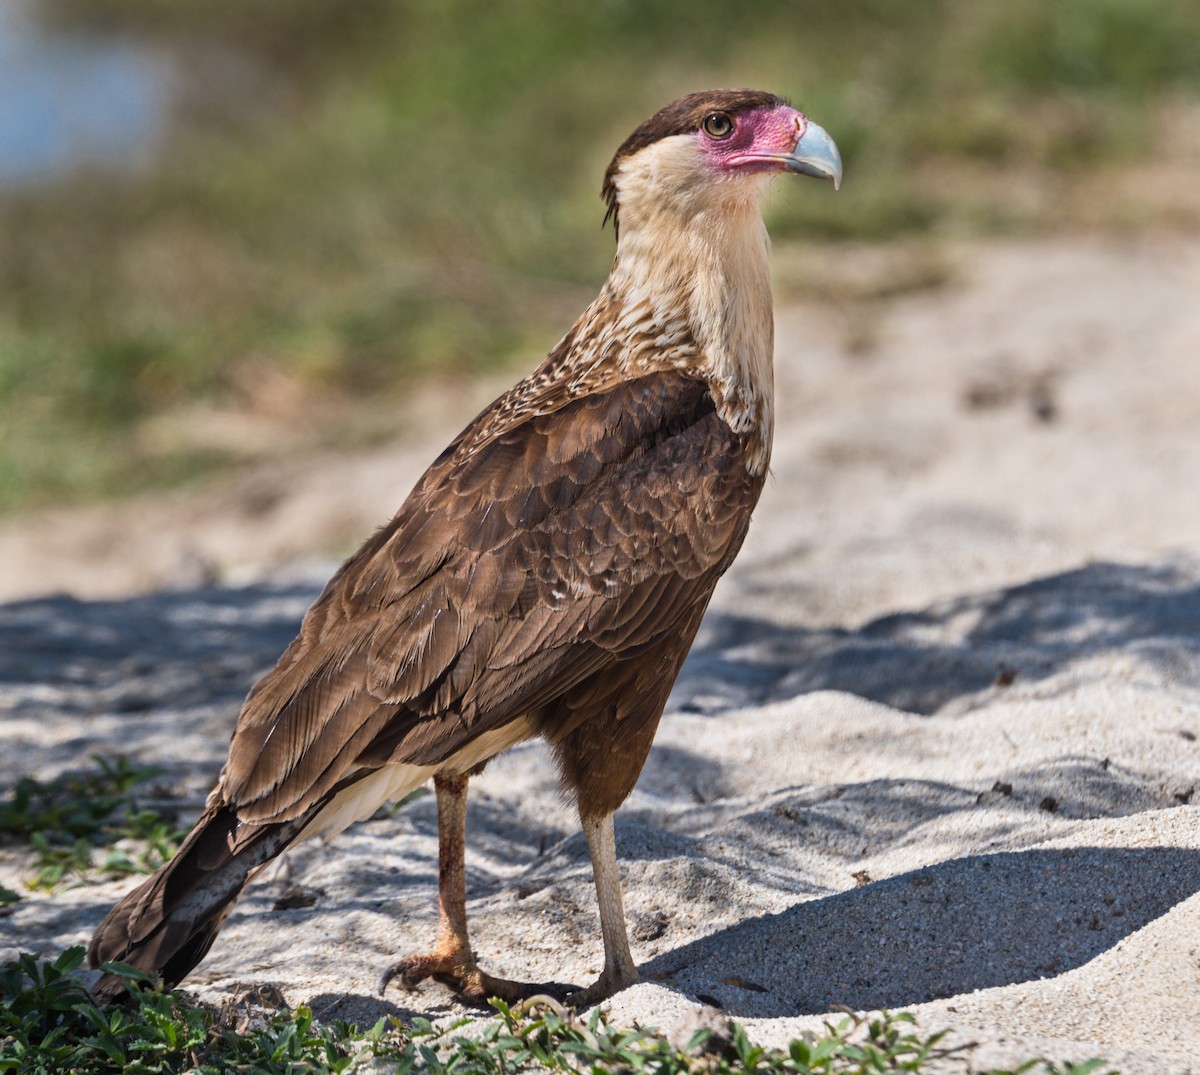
[672,560,1200,714]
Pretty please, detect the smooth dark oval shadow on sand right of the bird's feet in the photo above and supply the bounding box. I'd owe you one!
[641,847,1200,1017]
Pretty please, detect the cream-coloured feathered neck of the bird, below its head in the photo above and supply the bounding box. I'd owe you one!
[601,192,774,468]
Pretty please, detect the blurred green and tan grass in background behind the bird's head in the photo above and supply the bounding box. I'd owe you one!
[0,0,1200,512]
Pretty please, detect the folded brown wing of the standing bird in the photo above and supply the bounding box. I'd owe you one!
[223,373,761,821]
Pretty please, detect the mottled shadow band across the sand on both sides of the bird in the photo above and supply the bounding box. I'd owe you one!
[0,560,1200,745]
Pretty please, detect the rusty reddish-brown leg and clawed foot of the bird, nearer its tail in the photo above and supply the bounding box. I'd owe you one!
[379,774,544,1004]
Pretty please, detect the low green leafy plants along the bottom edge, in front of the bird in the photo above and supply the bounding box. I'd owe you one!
[0,948,1106,1075]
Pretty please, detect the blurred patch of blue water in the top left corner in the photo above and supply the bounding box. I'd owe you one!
[0,0,172,186]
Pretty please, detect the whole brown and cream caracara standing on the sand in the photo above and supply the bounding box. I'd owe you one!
[88,89,841,1007]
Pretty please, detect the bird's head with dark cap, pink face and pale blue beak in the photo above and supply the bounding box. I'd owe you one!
[601,90,841,237]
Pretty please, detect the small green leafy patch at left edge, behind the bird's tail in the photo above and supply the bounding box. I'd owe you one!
[0,755,184,903]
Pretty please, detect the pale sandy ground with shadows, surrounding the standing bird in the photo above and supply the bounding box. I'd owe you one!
[0,238,1200,1075]
